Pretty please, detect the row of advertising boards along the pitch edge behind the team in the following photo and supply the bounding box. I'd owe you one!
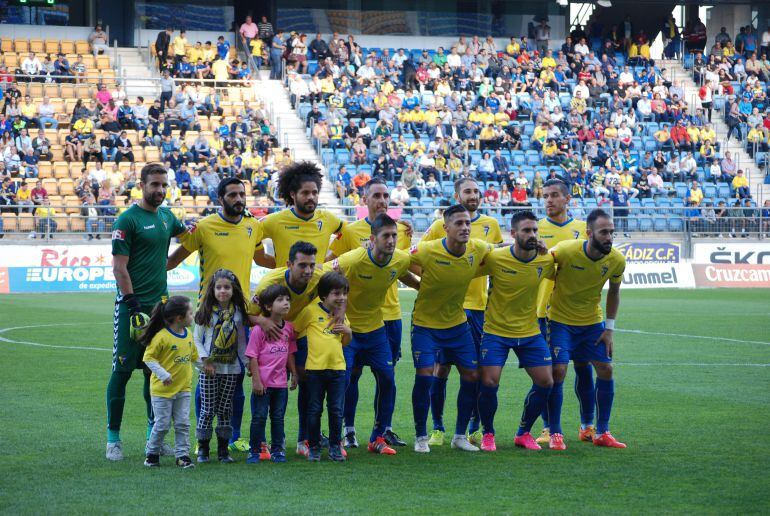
[0,241,770,294]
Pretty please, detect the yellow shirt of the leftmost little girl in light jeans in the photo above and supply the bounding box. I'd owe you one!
[143,328,199,398]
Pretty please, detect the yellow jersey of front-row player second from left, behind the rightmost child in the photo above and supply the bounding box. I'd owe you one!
[324,247,411,333]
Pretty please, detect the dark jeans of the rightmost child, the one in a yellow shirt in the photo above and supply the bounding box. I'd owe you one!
[305,369,345,448]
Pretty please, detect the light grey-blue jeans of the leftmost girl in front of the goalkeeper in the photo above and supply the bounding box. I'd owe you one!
[147,392,190,458]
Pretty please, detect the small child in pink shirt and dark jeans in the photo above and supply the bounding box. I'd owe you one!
[245,285,297,464]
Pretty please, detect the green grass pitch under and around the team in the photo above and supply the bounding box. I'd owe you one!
[0,290,770,514]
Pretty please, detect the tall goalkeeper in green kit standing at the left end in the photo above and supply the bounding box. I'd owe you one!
[107,163,186,460]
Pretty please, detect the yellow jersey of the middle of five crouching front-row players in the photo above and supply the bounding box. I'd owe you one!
[411,238,492,330]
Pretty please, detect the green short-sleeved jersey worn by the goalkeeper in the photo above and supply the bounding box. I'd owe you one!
[112,204,186,306]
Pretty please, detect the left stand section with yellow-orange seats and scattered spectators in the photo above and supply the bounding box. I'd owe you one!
[0,33,284,238]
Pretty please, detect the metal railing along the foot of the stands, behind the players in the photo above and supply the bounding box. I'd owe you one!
[0,204,770,242]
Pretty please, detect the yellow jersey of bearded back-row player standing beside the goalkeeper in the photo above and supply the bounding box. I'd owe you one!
[179,213,262,299]
